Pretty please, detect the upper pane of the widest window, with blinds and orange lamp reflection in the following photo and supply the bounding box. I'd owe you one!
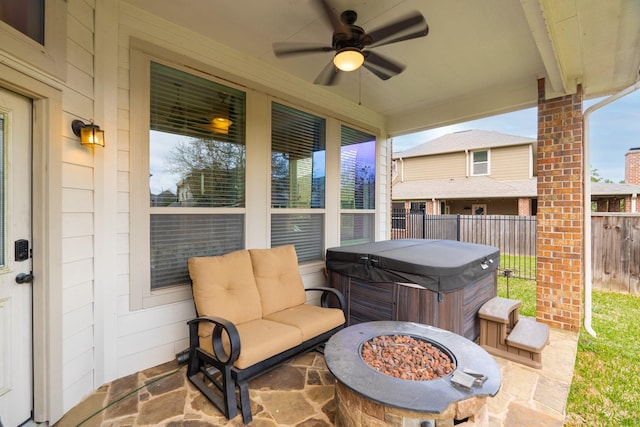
[149,62,246,207]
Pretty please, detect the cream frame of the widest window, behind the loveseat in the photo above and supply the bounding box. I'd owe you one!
[129,47,247,310]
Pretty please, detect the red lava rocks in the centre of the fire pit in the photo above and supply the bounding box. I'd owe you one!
[361,335,456,381]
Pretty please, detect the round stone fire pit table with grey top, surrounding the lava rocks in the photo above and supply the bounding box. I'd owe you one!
[324,321,502,427]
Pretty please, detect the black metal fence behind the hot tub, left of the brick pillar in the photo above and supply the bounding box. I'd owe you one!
[391,213,537,280]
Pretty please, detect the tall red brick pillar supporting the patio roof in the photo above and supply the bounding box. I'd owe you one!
[536,79,584,331]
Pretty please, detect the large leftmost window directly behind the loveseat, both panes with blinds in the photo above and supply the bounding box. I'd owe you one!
[130,55,246,308]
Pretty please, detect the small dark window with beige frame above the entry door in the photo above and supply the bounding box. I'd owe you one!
[0,0,67,79]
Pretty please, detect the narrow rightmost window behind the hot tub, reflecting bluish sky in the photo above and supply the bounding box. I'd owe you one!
[340,125,376,245]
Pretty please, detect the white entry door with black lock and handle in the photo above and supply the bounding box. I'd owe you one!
[0,88,33,427]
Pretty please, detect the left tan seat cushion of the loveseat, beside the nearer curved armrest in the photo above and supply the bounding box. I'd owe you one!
[200,319,302,369]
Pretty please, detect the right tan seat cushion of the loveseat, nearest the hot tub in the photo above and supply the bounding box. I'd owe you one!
[265,304,345,341]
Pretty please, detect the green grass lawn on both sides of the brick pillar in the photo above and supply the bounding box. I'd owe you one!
[498,276,640,426]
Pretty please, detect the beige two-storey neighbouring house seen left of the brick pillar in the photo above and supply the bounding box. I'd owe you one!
[392,130,537,215]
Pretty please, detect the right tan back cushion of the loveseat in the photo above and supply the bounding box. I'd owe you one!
[249,245,307,316]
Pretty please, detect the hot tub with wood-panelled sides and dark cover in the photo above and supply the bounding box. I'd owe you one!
[327,241,499,341]
